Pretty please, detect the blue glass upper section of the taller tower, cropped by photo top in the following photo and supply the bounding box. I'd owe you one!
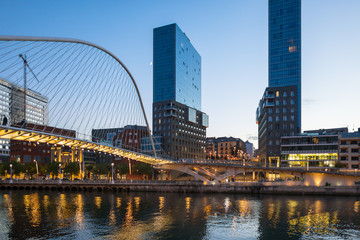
[269,0,301,131]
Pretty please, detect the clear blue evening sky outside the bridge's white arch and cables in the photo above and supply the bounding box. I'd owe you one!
[0,0,360,148]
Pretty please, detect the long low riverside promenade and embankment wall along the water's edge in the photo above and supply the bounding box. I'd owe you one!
[0,180,360,196]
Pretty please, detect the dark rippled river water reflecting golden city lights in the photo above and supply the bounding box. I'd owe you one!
[0,190,360,240]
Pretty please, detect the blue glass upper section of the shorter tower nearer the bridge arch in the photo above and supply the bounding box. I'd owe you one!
[153,24,201,110]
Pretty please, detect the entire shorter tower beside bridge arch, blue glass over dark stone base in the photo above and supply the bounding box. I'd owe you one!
[153,24,208,159]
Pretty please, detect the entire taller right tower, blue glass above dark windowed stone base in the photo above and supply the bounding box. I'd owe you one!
[256,0,301,165]
